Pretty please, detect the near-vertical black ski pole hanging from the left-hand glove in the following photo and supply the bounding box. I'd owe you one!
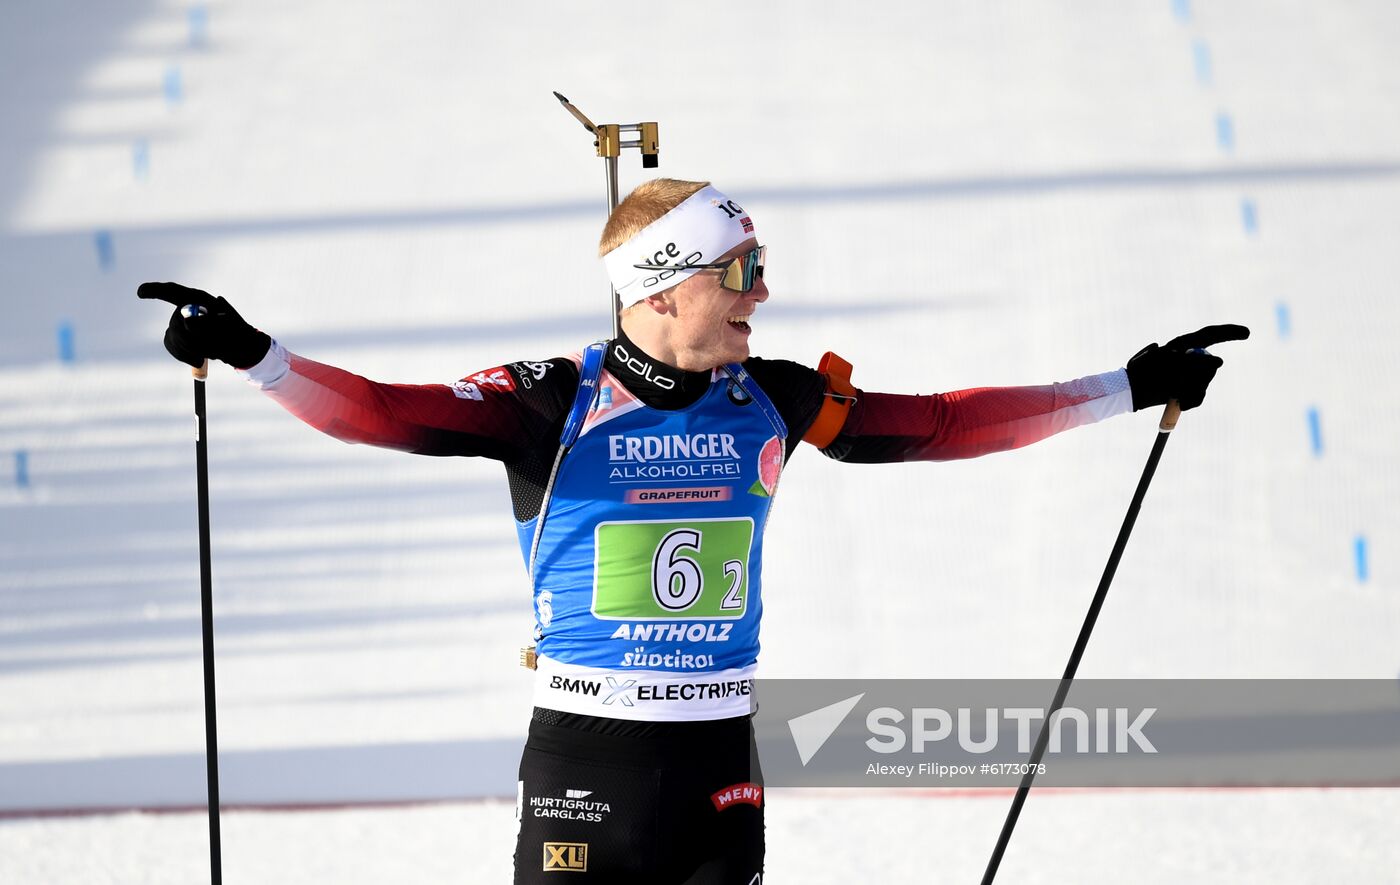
[181,304,224,885]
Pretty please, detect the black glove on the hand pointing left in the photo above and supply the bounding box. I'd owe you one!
[136,283,272,368]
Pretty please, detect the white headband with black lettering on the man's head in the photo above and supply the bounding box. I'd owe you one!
[603,186,753,304]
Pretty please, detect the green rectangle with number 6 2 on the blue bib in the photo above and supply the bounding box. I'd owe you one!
[592,517,753,620]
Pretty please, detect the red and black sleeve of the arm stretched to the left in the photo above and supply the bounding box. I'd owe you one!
[242,342,571,461]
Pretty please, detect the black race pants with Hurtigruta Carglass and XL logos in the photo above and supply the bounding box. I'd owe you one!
[515,710,763,885]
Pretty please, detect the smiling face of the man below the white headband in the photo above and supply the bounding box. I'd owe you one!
[655,237,769,371]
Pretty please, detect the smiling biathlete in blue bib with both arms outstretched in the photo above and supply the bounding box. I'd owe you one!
[139,179,1247,885]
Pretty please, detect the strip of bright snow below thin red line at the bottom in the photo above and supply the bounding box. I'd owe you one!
[0,790,1400,885]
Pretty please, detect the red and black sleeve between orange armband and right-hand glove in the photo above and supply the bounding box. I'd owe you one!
[823,370,1133,464]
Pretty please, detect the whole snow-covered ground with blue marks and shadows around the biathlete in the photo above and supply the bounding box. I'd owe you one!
[0,0,1400,885]
